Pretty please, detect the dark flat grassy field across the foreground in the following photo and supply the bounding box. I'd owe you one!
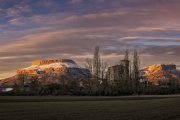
[0,96,180,120]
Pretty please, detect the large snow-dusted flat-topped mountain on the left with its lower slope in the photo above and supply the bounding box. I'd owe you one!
[0,59,90,85]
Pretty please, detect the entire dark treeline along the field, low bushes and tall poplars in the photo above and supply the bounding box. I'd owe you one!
[1,46,180,96]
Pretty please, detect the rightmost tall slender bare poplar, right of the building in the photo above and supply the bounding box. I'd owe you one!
[132,50,140,93]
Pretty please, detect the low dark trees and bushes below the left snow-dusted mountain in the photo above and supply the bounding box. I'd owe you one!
[11,77,88,95]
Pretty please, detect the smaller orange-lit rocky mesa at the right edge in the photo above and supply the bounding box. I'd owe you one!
[140,64,180,85]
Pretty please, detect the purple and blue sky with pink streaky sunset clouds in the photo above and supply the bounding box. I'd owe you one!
[0,0,180,79]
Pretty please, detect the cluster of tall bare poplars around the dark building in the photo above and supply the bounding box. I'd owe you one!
[85,46,141,95]
